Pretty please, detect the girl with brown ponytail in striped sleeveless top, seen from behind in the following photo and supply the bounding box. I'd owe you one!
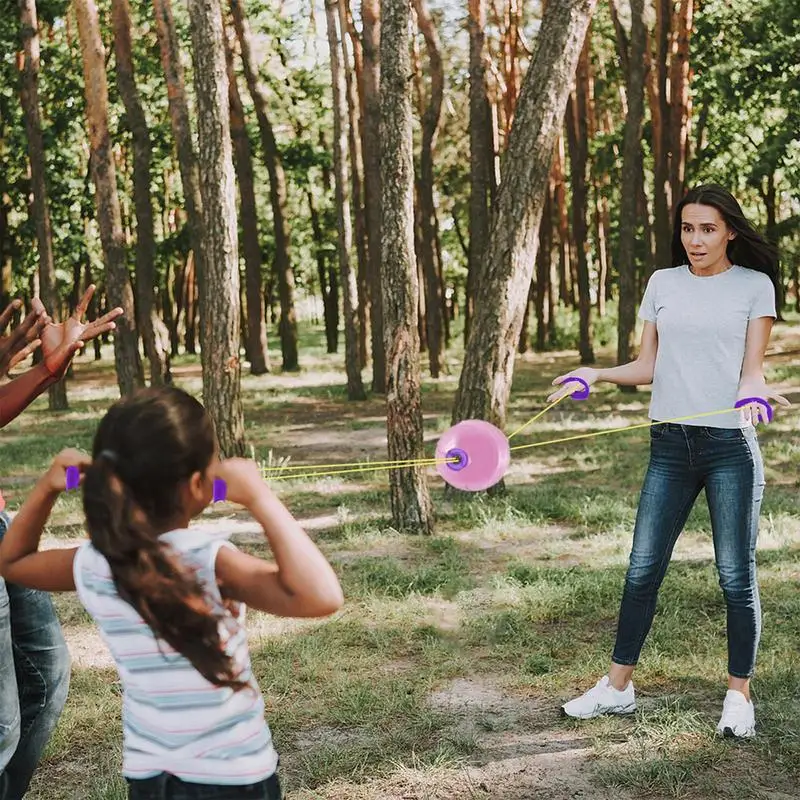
[0,388,342,800]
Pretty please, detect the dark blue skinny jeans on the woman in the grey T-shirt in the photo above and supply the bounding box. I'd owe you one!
[612,423,764,678]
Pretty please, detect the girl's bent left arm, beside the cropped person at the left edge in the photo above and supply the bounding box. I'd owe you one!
[0,450,91,592]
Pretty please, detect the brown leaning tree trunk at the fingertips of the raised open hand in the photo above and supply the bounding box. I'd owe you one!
[74,0,144,396]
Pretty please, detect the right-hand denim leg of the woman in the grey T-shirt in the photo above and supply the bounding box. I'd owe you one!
[706,428,765,678]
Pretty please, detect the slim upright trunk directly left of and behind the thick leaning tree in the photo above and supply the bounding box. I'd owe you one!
[464,0,494,344]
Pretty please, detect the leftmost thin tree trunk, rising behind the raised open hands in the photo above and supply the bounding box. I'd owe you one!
[19,0,69,411]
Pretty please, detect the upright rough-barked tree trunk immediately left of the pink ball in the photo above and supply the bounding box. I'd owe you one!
[380,0,433,534]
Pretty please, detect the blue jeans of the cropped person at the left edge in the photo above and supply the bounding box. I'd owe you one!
[0,512,70,800]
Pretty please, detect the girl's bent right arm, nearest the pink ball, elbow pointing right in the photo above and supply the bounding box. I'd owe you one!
[216,459,344,617]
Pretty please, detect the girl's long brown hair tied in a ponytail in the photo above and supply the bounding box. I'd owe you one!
[83,388,248,690]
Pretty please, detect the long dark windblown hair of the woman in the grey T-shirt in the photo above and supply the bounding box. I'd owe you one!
[672,183,780,296]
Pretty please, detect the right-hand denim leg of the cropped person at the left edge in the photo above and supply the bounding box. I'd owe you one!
[0,515,70,800]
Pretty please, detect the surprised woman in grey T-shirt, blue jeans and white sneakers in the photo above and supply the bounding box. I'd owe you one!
[548,185,789,738]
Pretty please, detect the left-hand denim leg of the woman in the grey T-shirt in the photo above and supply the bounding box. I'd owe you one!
[612,424,703,666]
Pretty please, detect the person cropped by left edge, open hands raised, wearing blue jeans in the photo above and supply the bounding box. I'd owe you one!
[0,286,122,800]
